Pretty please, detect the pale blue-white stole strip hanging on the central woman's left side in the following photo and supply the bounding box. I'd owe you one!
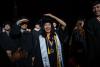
[39,35,50,67]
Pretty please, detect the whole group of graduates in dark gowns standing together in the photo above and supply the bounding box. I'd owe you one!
[0,1,100,67]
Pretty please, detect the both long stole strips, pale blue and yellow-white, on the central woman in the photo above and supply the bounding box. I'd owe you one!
[39,33,64,67]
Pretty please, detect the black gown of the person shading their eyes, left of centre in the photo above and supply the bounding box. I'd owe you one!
[17,31,34,67]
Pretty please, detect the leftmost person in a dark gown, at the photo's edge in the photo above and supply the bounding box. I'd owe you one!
[0,23,14,67]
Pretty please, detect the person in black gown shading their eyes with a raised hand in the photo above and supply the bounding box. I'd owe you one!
[12,19,34,67]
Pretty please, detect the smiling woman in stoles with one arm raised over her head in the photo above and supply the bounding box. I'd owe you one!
[35,14,66,67]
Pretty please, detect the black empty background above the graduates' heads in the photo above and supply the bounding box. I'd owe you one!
[0,0,95,25]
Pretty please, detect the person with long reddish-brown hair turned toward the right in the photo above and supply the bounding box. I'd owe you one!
[70,19,87,67]
